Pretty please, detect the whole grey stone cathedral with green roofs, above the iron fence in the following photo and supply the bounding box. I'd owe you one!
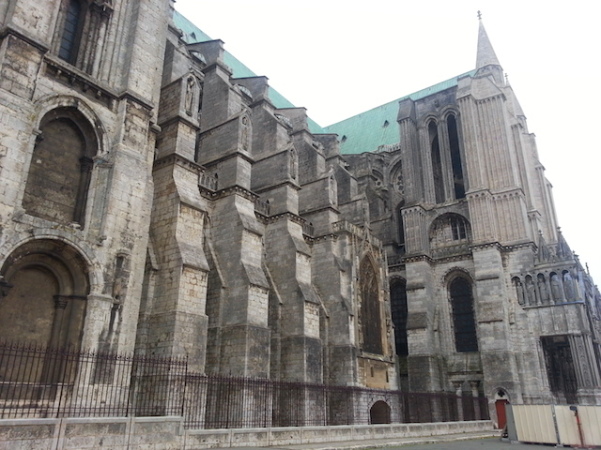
[0,0,601,418]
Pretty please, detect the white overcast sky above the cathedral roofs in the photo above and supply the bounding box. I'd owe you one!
[175,0,601,284]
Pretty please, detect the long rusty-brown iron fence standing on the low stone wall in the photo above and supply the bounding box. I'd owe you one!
[0,343,489,429]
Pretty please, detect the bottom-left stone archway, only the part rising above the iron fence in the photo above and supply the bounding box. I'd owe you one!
[0,239,90,347]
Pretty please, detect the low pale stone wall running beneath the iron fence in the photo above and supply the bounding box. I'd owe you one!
[0,417,493,450]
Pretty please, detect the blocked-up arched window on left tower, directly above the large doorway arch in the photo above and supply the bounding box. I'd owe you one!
[23,108,98,226]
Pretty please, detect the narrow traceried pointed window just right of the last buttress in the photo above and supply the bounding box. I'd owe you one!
[360,257,382,355]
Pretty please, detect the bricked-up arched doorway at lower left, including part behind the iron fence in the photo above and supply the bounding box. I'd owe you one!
[0,239,90,390]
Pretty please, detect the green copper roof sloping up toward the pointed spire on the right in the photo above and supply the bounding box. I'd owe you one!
[323,70,475,155]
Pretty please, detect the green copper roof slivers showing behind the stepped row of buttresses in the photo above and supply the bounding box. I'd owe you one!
[173,11,323,133]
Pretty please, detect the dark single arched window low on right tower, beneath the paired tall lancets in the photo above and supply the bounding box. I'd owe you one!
[449,277,478,352]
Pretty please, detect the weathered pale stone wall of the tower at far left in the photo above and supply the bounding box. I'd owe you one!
[0,0,169,362]
